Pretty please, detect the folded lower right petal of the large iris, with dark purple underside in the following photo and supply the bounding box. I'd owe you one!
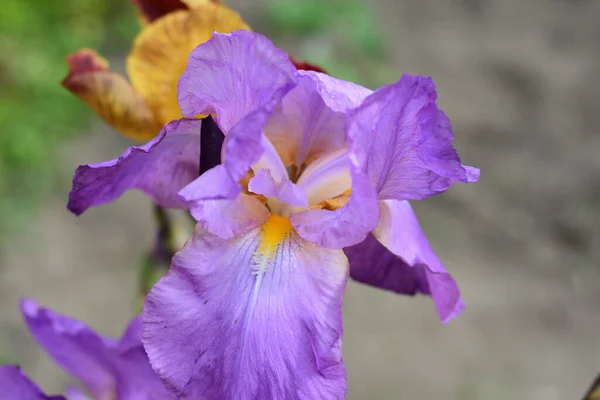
[344,200,464,322]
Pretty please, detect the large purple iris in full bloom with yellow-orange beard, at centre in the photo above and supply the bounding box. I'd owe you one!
[69,31,479,400]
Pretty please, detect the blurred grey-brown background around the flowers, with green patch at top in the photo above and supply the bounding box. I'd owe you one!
[0,0,600,400]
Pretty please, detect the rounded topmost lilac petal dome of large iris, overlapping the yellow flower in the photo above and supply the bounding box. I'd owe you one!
[178,31,296,135]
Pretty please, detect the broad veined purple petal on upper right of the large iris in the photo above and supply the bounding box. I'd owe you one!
[349,75,478,200]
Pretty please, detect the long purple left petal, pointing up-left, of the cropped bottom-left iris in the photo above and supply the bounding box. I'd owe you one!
[21,299,116,398]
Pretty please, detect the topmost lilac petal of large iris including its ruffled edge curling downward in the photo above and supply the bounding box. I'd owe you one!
[179,31,297,219]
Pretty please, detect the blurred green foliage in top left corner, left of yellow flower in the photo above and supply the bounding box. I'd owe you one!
[0,0,138,242]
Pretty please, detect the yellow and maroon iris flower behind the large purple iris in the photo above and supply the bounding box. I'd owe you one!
[62,0,250,140]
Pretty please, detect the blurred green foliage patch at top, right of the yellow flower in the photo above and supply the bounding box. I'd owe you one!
[266,0,393,87]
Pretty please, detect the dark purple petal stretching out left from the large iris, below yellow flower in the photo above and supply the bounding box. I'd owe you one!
[67,119,201,215]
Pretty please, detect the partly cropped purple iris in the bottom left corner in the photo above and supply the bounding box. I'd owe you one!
[13,299,176,400]
